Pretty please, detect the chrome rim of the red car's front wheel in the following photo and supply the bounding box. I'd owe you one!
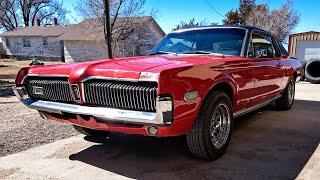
[210,104,231,149]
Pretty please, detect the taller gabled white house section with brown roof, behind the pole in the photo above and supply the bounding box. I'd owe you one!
[58,16,165,62]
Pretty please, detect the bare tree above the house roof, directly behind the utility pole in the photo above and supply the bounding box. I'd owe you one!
[76,0,146,45]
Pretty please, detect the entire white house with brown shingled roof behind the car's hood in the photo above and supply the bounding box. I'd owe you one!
[0,16,165,63]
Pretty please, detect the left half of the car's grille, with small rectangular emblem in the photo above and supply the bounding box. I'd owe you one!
[27,77,74,102]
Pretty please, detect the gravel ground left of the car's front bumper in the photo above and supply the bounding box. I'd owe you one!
[0,81,77,156]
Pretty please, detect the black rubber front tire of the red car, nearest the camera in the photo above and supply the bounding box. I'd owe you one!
[186,91,233,161]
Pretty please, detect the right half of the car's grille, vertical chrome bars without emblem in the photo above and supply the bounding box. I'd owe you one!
[84,80,158,112]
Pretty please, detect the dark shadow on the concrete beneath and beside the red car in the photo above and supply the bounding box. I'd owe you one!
[69,100,320,179]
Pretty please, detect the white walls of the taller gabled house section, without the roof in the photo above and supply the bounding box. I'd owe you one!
[64,21,163,63]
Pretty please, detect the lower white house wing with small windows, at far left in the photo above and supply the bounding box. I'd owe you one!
[0,25,70,60]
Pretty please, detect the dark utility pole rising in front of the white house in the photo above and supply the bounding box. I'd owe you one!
[104,0,112,59]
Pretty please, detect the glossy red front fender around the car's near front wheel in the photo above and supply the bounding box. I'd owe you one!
[159,66,237,136]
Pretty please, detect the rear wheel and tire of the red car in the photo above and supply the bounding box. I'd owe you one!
[276,77,296,111]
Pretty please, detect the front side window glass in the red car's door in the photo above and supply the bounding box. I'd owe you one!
[248,32,275,59]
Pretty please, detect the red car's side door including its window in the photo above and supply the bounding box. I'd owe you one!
[248,31,284,106]
